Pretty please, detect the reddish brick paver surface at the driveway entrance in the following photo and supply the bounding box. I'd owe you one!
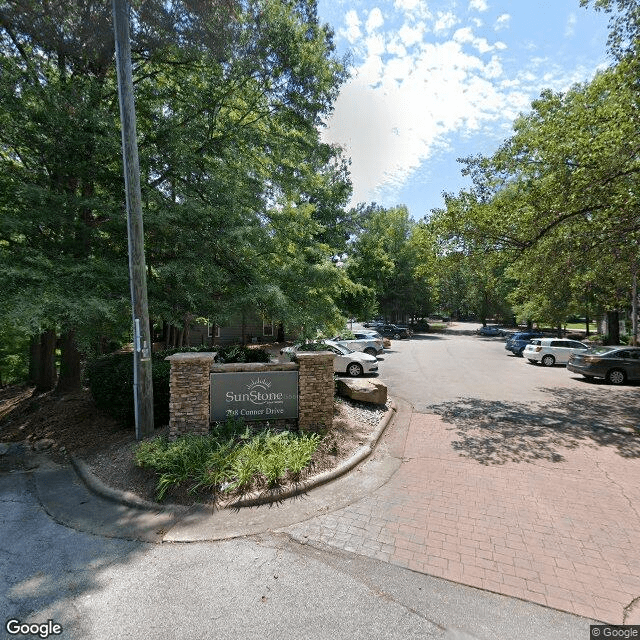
[288,413,640,623]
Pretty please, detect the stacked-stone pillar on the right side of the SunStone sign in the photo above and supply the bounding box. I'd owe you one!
[296,351,334,431]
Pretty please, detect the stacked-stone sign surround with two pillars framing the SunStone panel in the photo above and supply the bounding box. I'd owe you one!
[167,352,334,439]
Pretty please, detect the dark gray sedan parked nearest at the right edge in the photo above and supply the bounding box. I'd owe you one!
[567,347,640,384]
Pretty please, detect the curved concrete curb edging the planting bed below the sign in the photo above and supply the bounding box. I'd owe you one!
[71,400,397,513]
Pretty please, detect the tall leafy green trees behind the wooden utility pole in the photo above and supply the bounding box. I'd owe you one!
[0,0,350,384]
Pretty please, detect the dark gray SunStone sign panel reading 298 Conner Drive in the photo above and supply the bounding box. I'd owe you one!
[211,371,298,422]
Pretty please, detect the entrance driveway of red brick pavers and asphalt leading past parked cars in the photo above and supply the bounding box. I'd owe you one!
[293,335,640,623]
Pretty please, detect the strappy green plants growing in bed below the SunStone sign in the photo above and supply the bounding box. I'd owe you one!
[136,420,320,500]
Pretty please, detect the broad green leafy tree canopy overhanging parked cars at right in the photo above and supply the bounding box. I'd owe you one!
[430,60,640,336]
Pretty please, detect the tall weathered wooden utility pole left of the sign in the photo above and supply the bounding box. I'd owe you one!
[113,0,153,440]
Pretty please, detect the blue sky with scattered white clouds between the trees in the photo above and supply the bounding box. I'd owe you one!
[318,0,610,220]
